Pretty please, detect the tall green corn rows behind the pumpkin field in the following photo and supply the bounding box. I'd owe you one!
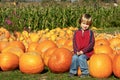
[0,2,120,31]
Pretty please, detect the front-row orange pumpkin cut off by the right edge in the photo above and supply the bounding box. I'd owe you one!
[112,54,120,78]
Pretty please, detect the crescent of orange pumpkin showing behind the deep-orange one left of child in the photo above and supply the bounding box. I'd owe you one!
[43,47,57,66]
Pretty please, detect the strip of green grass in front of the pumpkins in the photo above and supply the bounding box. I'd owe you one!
[0,69,118,80]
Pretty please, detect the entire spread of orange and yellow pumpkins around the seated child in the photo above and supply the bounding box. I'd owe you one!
[0,27,120,78]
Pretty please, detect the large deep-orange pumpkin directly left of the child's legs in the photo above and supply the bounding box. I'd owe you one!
[48,48,72,73]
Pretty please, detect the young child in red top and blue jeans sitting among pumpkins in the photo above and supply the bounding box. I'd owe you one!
[69,14,95,77]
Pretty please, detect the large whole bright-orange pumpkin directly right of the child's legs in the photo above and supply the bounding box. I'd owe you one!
[89,54,112,78]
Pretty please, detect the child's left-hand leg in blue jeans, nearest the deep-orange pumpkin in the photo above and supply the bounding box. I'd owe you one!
[69,54,78,74]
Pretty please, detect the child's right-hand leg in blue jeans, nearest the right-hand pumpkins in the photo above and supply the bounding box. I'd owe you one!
[78,54,89,75]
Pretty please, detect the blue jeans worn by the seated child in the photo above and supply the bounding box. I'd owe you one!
[69,54,89,75]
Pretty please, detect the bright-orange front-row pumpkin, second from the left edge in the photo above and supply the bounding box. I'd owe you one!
[19,51,44,74]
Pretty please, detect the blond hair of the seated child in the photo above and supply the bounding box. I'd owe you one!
[79,14,92,26]
